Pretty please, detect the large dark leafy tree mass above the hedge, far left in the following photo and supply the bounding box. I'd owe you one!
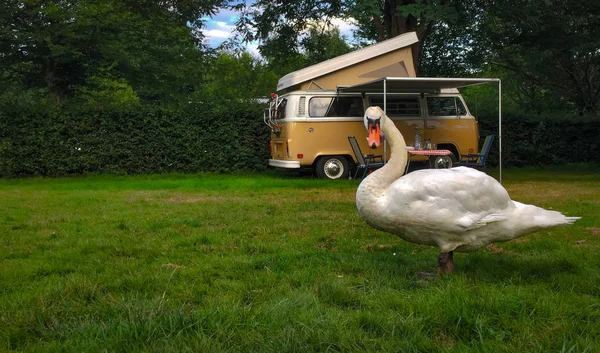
[0,0,224,104]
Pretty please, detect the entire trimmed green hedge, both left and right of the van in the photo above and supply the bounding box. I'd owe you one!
[0,102,600,177]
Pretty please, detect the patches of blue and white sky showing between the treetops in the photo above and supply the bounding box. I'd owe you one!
[202,9,356,56]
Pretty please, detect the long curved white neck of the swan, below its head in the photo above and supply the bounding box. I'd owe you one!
[361,116,407,191]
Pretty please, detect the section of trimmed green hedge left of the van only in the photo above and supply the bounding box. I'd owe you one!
[0,104,269,177]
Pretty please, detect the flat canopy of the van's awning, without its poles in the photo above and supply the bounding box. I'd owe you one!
[337,77,500,93]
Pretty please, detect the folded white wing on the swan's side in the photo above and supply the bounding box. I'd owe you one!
[387,167,514,233]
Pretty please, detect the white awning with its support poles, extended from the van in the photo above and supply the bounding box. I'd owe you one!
[337,77,502,183]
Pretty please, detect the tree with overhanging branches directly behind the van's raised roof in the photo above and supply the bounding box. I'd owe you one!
[236,0,468,74]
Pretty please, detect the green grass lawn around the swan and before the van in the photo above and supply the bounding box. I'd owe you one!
[0,167,600,352]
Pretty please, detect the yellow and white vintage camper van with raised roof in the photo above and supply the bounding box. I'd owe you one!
[263,33,479,179]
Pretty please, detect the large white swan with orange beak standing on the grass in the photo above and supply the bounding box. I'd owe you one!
[356,106,580,274]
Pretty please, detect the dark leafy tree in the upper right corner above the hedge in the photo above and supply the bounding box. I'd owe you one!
[477,0,600,116]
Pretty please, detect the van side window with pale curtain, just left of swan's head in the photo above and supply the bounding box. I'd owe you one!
[308,96,365,118]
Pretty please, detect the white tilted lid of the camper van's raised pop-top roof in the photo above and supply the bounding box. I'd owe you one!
[277,32,419,91]
